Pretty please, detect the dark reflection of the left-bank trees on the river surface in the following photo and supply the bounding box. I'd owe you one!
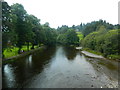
[2,47,56,88]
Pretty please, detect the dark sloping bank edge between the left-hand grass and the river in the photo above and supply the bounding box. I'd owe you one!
[2,46,46,64]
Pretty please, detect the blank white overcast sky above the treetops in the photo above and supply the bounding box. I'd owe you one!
[5,0,119,28]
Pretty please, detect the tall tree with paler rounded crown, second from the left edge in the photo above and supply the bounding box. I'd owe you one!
[11,3,27,53]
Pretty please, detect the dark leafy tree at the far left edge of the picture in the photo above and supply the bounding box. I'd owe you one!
[2,2,17,57]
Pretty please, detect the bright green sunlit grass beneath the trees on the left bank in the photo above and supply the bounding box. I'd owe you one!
[3,45,38,58]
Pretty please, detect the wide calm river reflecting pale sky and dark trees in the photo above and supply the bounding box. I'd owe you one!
[2,46,118,88]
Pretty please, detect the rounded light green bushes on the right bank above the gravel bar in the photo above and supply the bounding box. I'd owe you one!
[82,26,118,56]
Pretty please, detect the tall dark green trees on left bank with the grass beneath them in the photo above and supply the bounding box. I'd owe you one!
[2,2,57,57]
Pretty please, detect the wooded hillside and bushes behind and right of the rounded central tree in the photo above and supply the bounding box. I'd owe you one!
[57,20,120,59]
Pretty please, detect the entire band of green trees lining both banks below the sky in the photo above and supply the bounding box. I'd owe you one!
[2,2,120,59]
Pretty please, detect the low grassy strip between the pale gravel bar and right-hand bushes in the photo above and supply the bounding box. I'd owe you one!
[82,48,120,60]
